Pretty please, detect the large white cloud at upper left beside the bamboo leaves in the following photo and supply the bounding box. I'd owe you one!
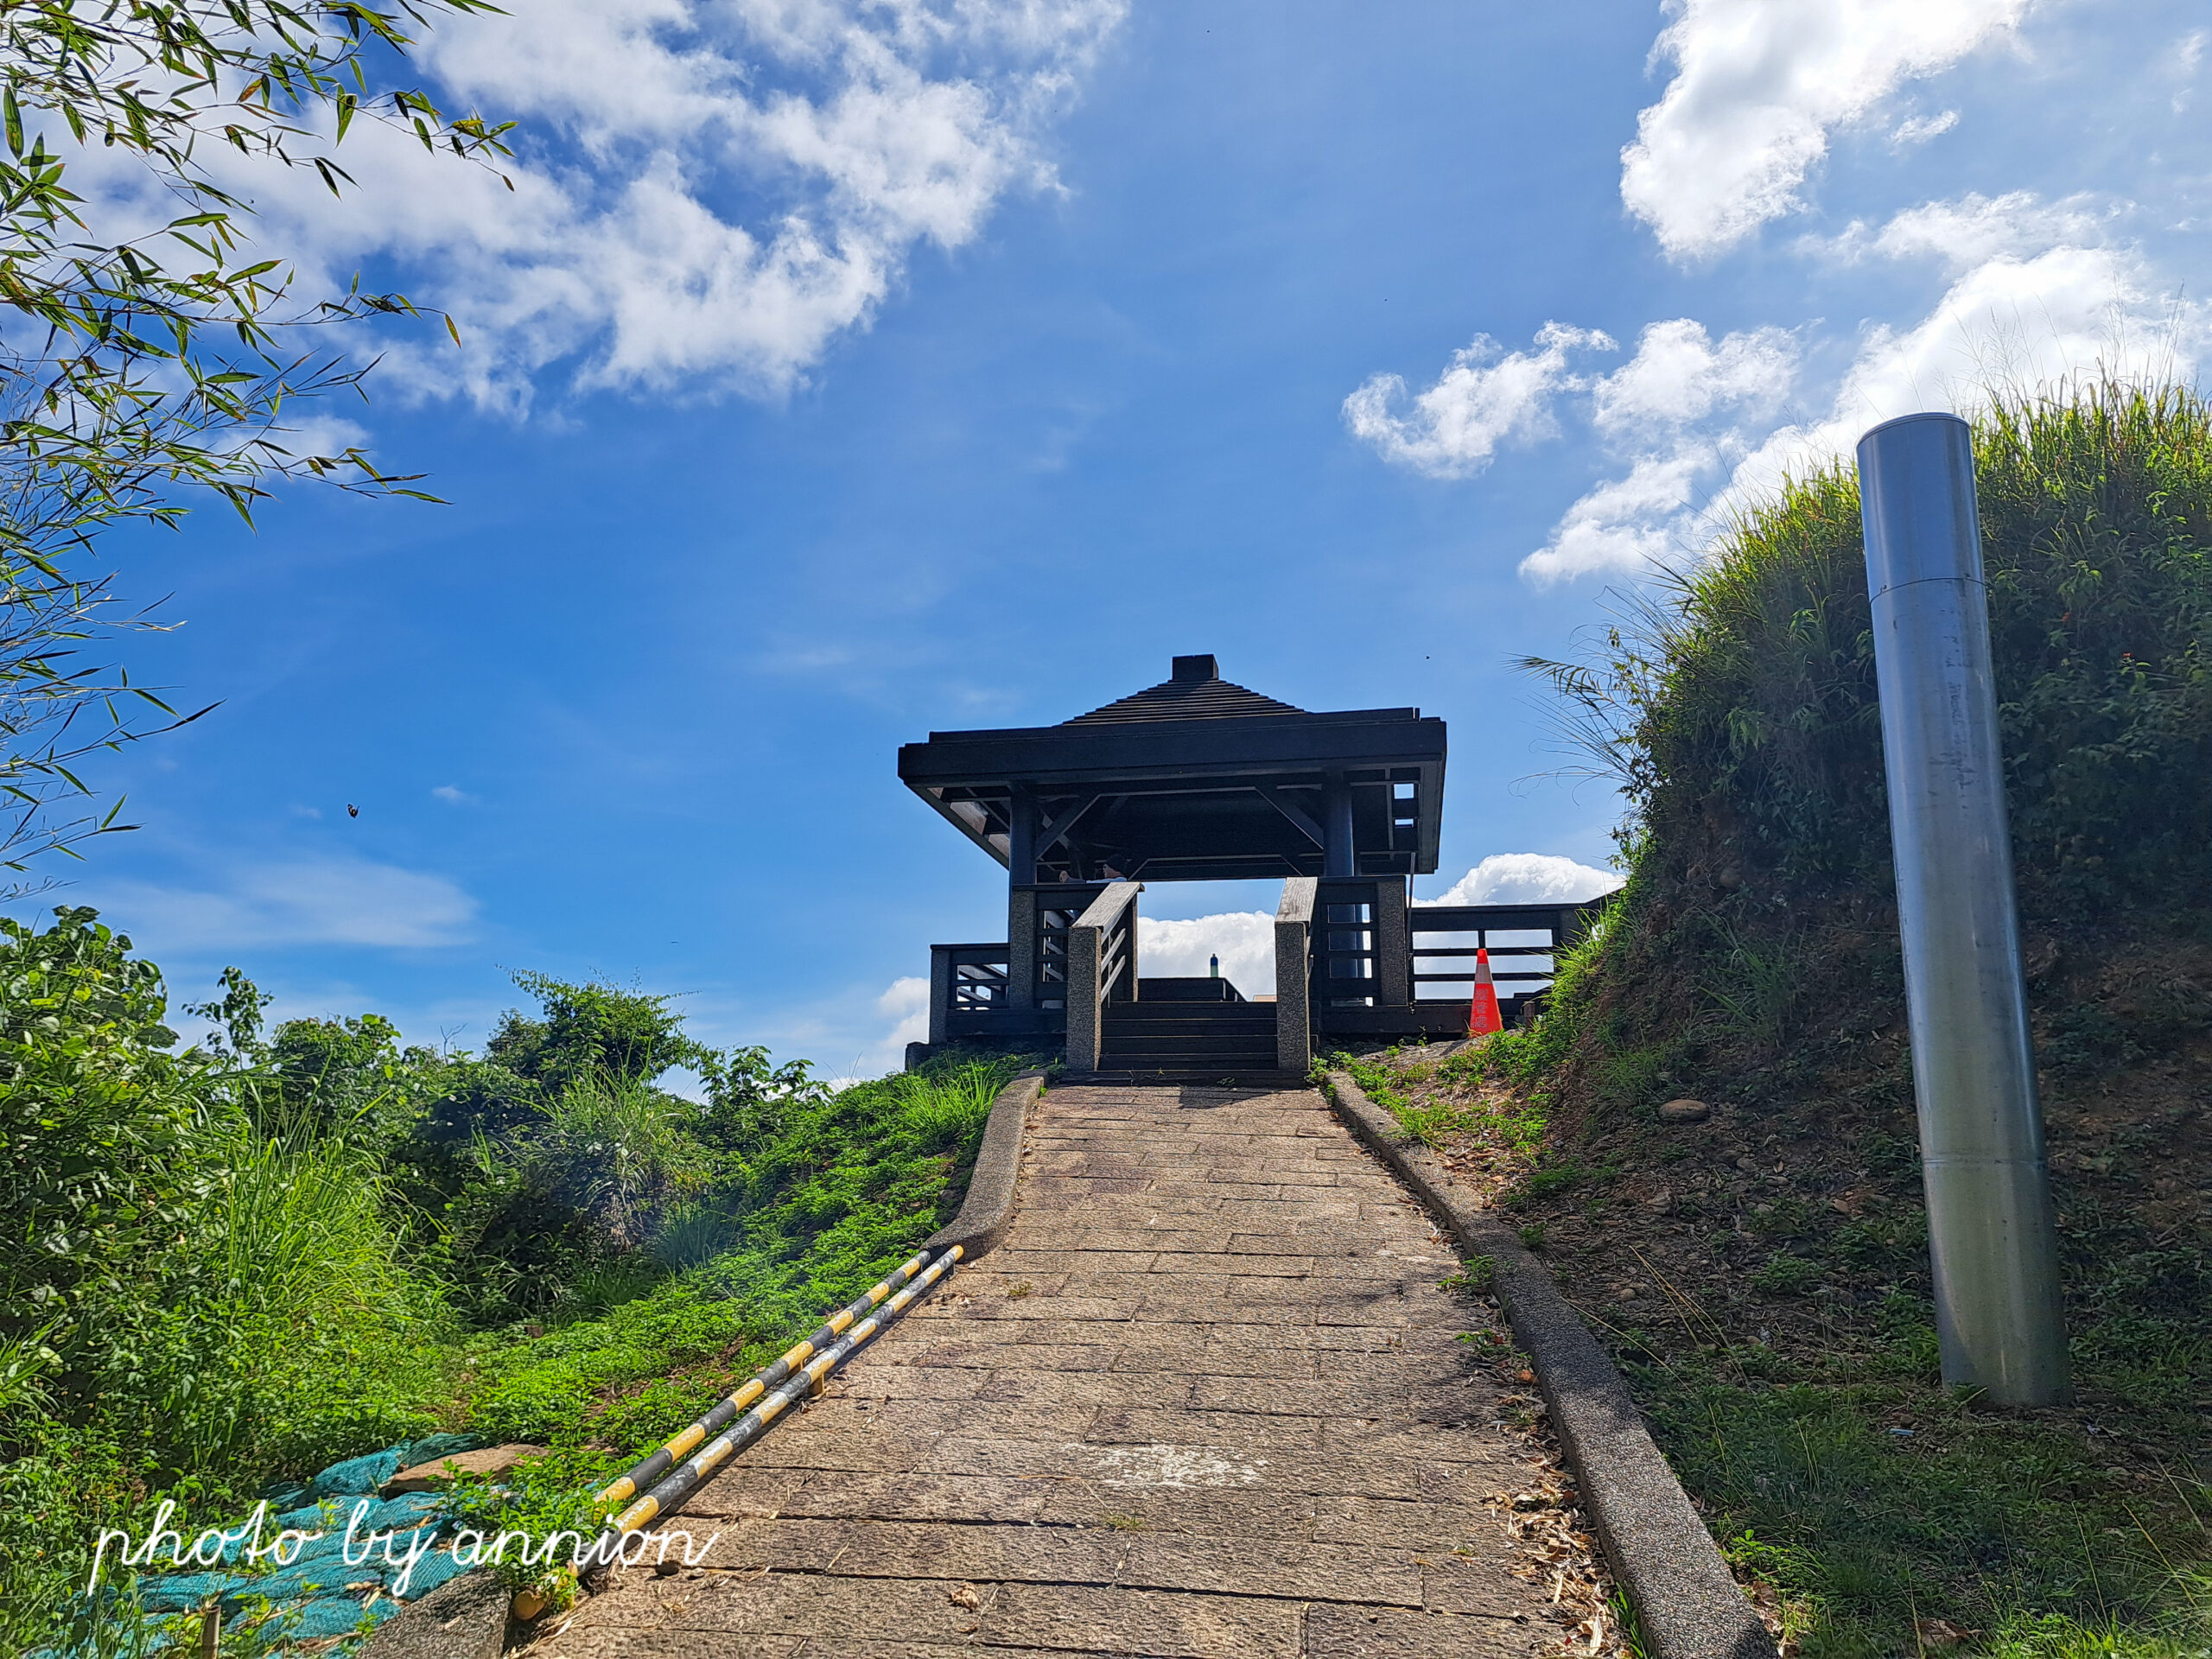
[71,0,1126,410]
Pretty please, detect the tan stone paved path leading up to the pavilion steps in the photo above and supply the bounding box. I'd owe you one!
[531,1086,1560,1659]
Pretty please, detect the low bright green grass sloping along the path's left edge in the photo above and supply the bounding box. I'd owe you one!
[0,1059,1018,1652]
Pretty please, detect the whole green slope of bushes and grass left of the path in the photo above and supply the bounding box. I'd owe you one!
[0,909,955,1652]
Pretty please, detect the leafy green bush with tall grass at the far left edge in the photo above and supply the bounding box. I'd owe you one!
[0,909,449,1650]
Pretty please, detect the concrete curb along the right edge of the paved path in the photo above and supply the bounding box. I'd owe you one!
[1327,1071,1777,1659]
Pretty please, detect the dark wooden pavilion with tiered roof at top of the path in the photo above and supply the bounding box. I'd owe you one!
[898,657,1610,1082]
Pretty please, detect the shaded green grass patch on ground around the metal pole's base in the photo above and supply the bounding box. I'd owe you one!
[1637,1360,2212,1659]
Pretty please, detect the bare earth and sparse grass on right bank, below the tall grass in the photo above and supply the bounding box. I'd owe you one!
[1365,918,2212,1655]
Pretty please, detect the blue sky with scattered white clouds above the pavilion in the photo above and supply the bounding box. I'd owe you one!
[17,0,2212,1075]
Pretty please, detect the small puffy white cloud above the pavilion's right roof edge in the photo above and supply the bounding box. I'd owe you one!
[1344,323,1615,478]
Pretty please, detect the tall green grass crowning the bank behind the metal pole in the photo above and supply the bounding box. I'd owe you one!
[1531,383,2212,912]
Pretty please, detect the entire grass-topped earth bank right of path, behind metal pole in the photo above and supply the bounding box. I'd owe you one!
[1327,390,2212,1655]
